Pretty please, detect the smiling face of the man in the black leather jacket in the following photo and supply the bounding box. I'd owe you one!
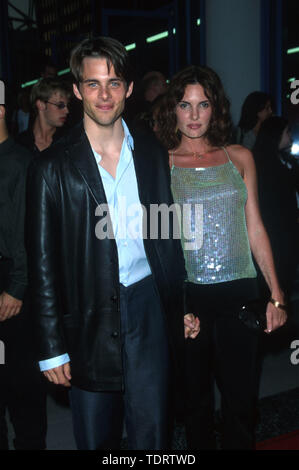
[74,57,133,127]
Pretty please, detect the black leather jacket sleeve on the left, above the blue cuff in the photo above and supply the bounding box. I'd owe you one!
[26,159,66,360]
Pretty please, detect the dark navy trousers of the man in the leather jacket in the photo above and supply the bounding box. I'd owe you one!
[70,277,170,450]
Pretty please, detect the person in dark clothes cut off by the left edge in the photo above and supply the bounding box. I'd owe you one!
[0,105,47,450]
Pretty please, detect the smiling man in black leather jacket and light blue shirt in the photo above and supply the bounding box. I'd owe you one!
[28,38,198,450]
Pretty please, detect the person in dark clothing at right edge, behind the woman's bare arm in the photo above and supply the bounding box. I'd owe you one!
[252,116,299,302]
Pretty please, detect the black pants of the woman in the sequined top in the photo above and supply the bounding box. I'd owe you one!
[185,279,259,449]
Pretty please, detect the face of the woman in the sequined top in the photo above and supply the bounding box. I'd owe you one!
[175,84,212,139]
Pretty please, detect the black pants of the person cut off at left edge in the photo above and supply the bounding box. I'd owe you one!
[0,261,47,450]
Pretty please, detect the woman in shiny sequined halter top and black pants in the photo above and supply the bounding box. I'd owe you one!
[159,66,286,449]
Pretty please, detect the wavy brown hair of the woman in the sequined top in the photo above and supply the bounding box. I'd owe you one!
[157,65,232,149]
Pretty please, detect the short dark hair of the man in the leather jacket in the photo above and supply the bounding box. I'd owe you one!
[70,37,132,86]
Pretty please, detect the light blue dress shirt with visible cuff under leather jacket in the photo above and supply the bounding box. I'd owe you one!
[39,121,151,371]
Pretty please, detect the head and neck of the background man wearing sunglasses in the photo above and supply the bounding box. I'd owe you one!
[17,78,71,155]
